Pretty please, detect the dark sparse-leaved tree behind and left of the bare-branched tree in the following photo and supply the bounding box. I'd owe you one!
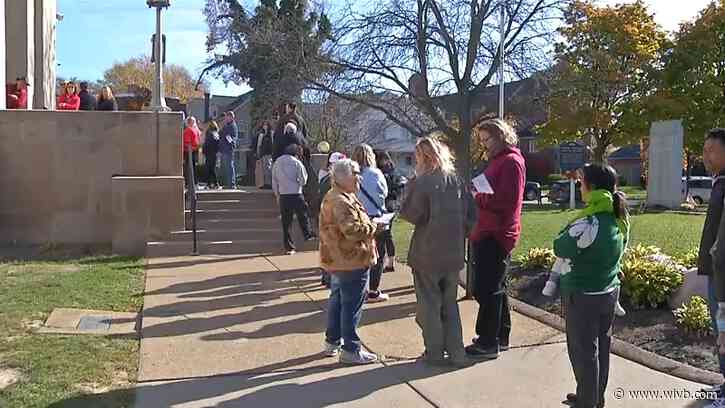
[202,0,331,120]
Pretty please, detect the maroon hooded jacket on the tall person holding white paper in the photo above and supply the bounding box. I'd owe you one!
[471,147,526,254]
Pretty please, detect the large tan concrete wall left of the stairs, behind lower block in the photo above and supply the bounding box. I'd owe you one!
[0,111,183,245]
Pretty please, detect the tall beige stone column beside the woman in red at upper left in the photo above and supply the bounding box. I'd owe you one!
[32,0,57,109]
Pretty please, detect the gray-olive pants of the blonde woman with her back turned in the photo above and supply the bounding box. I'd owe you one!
[413,270,466,360]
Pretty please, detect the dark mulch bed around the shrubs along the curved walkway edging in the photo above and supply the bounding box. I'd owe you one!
[508,266,719,372]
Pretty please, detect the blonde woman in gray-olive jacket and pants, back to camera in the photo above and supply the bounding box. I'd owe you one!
[400,137,469,367]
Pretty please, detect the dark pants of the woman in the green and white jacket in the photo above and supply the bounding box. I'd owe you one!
[562,289,619,408]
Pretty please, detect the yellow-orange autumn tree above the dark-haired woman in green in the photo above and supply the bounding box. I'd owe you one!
[540,0,666,162]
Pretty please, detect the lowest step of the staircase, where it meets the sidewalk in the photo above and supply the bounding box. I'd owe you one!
[146,239,318,258]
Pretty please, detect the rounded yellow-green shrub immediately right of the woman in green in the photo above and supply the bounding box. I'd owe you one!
[622,254,683,308]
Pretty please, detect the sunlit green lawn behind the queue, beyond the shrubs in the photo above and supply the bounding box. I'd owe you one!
[393,209,705,262]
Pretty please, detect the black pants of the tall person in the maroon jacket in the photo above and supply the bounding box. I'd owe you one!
[473,238,511,347]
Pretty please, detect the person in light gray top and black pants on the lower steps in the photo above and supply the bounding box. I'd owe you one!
[272,145,315,255]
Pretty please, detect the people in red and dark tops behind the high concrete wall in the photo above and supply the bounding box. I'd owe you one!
[5,77,118,111]
